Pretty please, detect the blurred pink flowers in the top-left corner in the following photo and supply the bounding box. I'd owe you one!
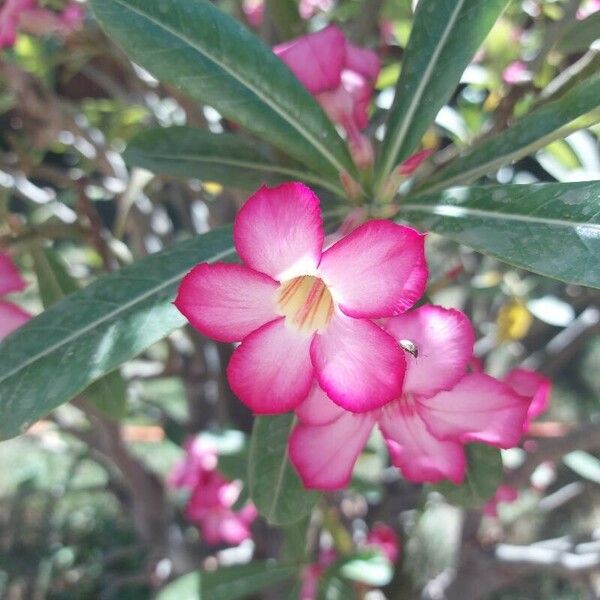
[0,0,85,48]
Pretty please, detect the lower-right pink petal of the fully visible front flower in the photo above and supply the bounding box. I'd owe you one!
[310,314,406,412]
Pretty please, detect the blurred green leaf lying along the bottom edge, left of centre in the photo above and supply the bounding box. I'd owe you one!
[156,561,298,600]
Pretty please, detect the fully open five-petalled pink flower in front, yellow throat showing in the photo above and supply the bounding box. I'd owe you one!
[175,183,427,414]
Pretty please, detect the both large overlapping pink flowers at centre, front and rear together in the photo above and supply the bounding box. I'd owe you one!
[175,183,544,490]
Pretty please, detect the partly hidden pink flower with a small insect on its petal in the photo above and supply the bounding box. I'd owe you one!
[289,305,528,490]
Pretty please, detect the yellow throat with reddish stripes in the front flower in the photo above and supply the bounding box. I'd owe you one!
[277,275,333,333]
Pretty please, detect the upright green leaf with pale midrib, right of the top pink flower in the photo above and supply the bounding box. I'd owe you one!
[375,0,508,190]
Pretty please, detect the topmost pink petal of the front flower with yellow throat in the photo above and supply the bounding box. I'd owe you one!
[233,182,324,281]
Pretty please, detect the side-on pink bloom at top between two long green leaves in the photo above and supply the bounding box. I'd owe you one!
[273,25,380,167]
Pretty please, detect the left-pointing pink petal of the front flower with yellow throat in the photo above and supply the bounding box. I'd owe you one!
[175,263,279,342]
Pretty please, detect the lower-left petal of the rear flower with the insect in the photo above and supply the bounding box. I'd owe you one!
[289,412,375,490]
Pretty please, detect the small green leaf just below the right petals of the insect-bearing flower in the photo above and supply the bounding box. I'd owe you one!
[432,444,502,508]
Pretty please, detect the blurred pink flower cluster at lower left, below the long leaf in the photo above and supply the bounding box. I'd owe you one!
[169,437,257,545]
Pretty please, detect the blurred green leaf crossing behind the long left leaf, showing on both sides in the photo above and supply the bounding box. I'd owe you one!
[31,246,127,419]
